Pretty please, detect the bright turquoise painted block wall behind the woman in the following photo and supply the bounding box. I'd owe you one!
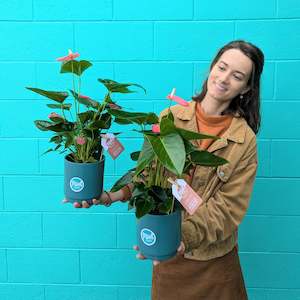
[0,0,300,300]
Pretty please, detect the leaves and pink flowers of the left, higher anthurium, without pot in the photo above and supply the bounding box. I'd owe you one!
[27,50,146,163]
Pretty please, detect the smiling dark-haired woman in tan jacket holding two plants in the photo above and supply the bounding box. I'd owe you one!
[77,40,264,300]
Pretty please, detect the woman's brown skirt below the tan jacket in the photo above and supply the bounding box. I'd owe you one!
[152,247,248,300]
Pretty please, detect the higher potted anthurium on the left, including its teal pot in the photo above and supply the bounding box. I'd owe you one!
[27,50,146,206]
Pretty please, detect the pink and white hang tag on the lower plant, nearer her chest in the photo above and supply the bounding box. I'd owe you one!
[170,179,203,215]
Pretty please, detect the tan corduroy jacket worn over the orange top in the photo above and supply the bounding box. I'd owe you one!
[161,101,257,260]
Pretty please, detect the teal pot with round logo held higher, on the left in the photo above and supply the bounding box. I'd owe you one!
[64,156,104,202]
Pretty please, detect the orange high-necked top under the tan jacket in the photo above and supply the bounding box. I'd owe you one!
[196,102,233,150]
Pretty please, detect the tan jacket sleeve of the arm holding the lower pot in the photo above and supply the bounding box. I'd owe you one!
[182,138,257,252]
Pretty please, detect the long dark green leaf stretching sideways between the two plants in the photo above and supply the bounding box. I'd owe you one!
[107,109,158,124]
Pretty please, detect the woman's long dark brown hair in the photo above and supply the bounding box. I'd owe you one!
[192,40,264,134]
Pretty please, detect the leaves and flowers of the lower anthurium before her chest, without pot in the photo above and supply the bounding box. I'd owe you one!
[111,94,227,218]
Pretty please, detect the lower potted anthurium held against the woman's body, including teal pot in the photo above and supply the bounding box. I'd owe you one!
[111,95,227,260]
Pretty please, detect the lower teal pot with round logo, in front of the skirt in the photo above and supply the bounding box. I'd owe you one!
[137,209,181,261]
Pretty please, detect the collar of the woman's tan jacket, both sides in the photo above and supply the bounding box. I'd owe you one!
[176,101,248,151]
